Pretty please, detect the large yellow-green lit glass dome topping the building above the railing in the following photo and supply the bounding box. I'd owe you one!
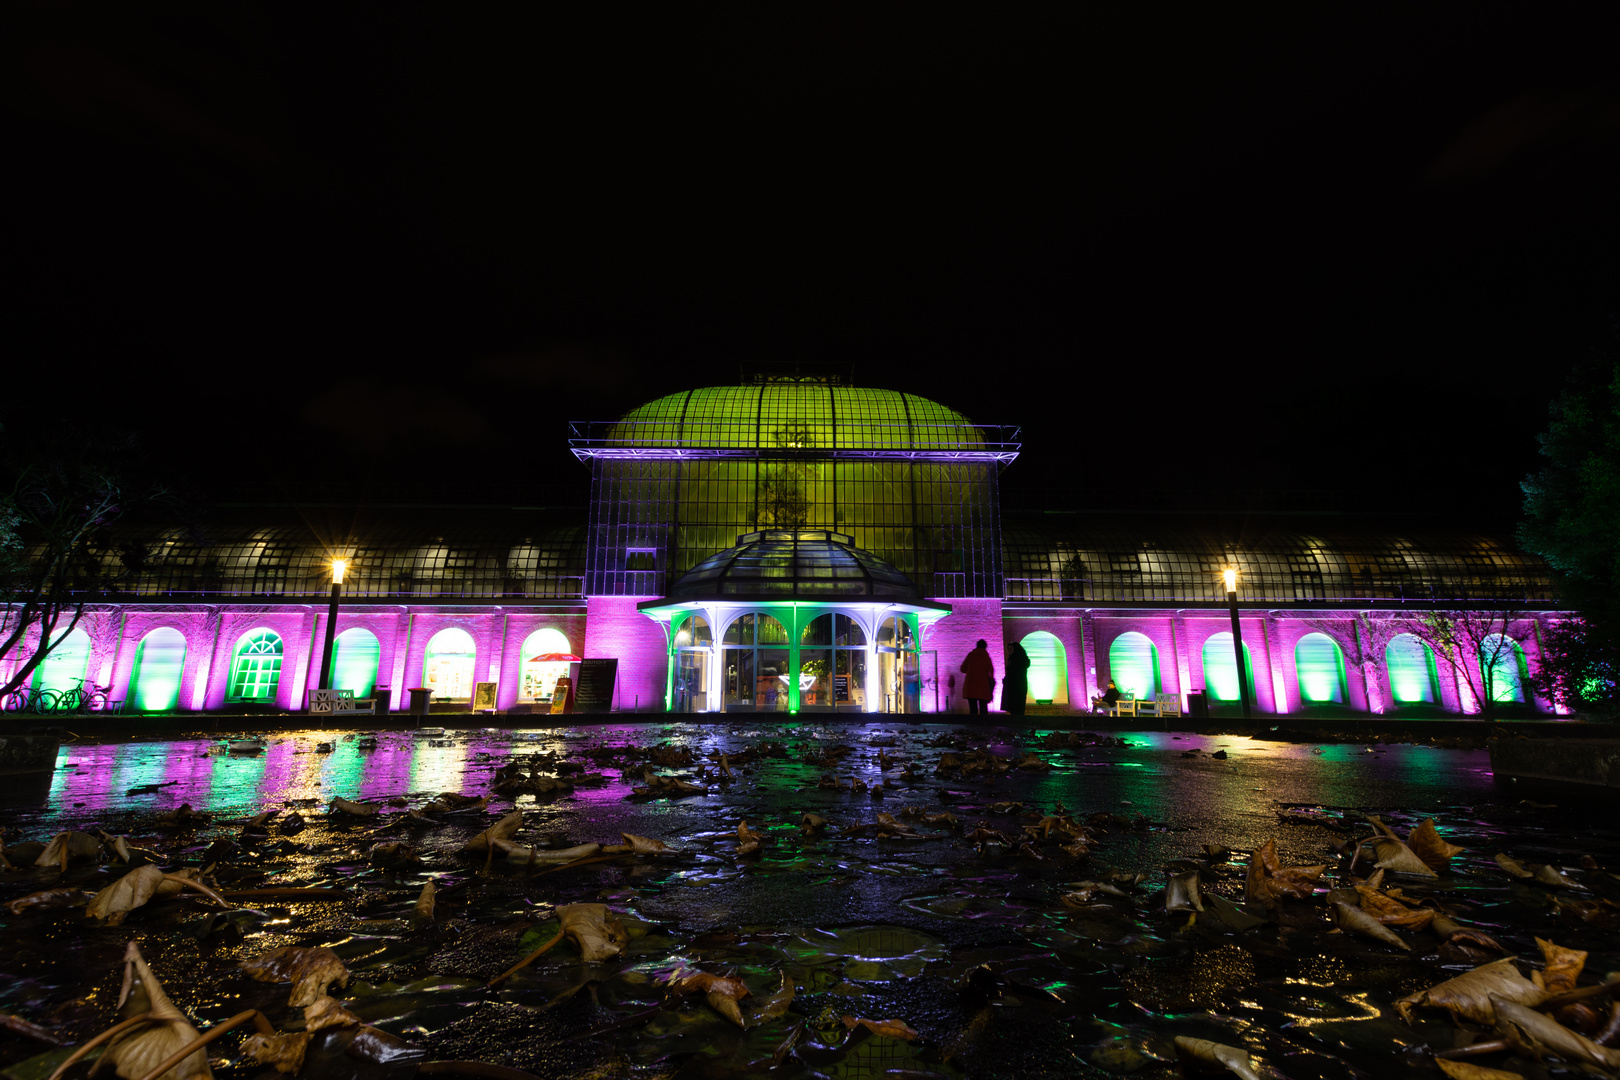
[609,382,985,452]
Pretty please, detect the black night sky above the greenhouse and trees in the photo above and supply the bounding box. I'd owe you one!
[0,2,1620,518]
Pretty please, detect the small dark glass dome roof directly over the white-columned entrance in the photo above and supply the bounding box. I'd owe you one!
[663,529,922,604]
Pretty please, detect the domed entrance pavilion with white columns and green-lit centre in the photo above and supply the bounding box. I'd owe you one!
[637,529,951,712]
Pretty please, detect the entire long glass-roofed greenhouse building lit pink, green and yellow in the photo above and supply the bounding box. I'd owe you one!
[0,377,1567,714]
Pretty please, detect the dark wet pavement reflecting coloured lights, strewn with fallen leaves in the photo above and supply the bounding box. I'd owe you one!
[0,724,1620,1080]
